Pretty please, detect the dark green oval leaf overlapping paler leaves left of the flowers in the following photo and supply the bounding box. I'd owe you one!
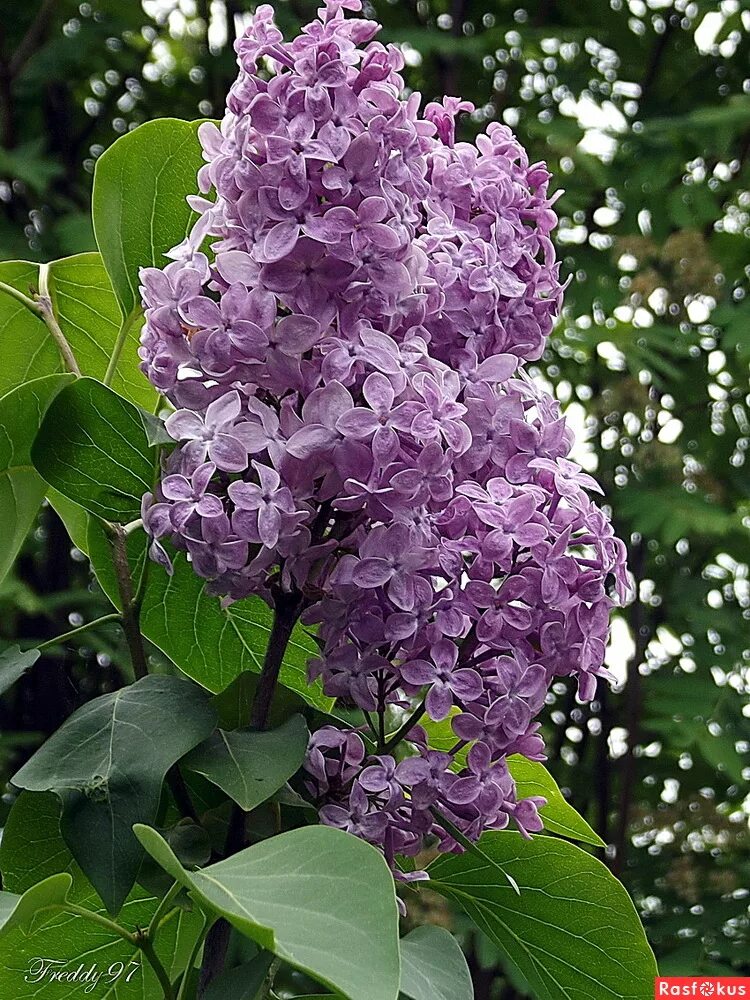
[31,378,154,522]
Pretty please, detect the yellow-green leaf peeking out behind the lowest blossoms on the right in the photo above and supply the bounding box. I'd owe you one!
[422,709,606,847]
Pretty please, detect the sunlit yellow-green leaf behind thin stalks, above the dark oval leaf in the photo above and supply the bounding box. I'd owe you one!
[49,253,156,410]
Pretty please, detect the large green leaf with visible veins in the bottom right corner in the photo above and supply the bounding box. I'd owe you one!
[430,833,658,1000]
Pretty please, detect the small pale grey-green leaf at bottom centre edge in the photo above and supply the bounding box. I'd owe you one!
[400,926,474,1000]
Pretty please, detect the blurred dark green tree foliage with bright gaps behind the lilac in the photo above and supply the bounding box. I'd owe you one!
[0,0,750,1000]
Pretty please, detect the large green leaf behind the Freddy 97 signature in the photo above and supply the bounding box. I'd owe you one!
[0,792,202,1000]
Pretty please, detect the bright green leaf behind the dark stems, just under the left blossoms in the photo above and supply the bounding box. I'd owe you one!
[88,523,333,712]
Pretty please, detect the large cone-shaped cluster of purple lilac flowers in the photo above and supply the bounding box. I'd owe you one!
[141,0,628,877]
